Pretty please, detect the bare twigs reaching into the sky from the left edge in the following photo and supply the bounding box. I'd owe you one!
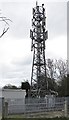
[0,10,12,38]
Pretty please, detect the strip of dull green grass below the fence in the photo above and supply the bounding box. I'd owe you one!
[2,111,69,120]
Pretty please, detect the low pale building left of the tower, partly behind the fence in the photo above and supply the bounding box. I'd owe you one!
[2,89,26,114]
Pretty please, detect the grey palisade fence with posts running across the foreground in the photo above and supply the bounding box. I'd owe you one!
[2,96,69,118]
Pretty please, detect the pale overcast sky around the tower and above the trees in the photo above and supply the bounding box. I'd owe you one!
[0,0,67,87]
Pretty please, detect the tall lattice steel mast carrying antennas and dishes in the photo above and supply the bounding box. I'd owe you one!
[30,2,48,96]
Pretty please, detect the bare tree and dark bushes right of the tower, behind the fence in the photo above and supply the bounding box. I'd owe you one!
[46,59,69,96]
